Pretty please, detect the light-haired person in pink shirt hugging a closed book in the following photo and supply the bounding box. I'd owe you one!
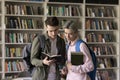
[63,21,94,80]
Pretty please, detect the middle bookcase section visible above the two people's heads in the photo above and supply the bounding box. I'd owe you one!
[46,2,83,31]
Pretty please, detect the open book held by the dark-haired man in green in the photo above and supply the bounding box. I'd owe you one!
[41,52,62,62]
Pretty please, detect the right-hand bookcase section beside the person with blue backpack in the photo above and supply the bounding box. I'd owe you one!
[85,4,120,80]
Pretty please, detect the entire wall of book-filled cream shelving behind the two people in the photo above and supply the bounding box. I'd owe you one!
[0,0,120,80]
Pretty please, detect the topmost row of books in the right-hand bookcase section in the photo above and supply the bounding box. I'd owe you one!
[86,6,116,17]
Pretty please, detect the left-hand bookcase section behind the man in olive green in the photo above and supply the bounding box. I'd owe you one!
[3,0,44,79]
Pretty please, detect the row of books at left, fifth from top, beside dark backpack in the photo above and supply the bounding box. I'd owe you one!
[5,60,26,72]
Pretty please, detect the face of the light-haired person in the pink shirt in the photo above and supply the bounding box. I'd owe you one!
[64,29,77,41]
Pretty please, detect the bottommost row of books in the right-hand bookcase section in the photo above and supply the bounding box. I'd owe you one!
[95,70,116,80]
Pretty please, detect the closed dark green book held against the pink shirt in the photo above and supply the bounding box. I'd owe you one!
[71,52,84,65]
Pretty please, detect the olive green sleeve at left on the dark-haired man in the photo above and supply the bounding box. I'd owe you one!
[31,37,43,66]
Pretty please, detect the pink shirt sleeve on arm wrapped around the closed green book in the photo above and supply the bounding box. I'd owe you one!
[71,43,94,73]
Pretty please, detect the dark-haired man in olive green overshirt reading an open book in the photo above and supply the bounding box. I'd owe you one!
[31,17,66,80]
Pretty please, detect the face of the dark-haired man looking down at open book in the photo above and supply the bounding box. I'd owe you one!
[46,25,59,39]
